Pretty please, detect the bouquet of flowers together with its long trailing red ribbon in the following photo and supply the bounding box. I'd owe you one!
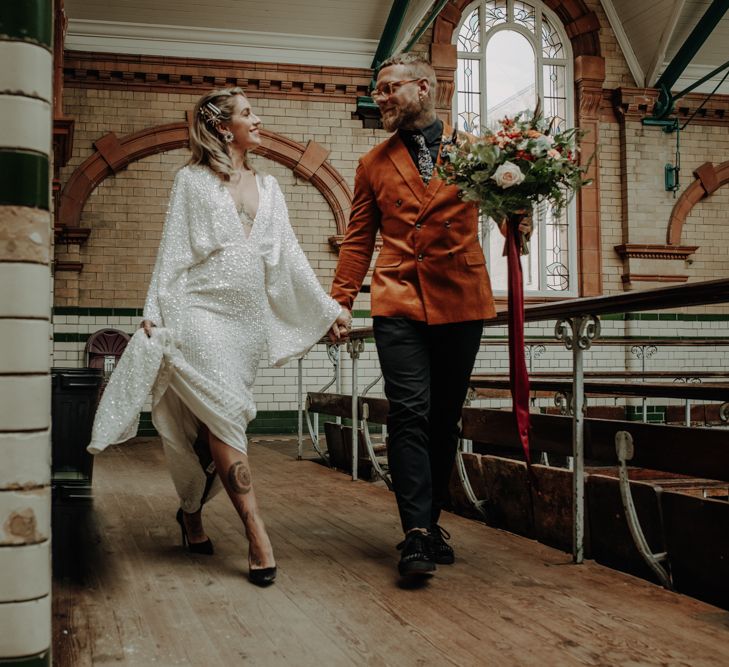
[438,105,589,470]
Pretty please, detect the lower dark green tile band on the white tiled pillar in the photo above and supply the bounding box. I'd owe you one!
[0,150,49,210]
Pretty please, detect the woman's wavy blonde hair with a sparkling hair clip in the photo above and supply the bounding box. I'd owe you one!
[188,88,253,181]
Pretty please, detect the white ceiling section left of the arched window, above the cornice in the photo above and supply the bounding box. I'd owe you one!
[65,0,433,68]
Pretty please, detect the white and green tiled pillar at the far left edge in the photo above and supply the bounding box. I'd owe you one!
[0,0,53,667]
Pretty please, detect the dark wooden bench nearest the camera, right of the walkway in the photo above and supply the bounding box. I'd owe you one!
[463,408,729,608]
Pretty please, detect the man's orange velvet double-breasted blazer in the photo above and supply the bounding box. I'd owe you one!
[331,127,496,324]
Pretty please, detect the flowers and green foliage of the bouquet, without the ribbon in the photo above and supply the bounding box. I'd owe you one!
[438,106,590,254]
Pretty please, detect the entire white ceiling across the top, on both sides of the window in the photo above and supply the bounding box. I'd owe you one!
[65,0,729,94]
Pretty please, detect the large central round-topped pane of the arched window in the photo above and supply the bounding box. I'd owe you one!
[486,30,536,127]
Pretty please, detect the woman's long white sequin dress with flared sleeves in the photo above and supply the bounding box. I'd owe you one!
[90,166,340,512]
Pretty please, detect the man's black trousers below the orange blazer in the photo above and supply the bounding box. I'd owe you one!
[373,317,483,532]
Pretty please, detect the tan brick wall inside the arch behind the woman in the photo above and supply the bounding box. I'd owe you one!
[74,149,344,308]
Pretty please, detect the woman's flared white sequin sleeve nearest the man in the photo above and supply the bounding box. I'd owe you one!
[261,176,341,366]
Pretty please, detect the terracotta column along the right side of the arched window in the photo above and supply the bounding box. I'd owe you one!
[575,55,605,296]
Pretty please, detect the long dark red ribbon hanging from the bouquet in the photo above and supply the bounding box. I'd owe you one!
[506,214,532,472]
